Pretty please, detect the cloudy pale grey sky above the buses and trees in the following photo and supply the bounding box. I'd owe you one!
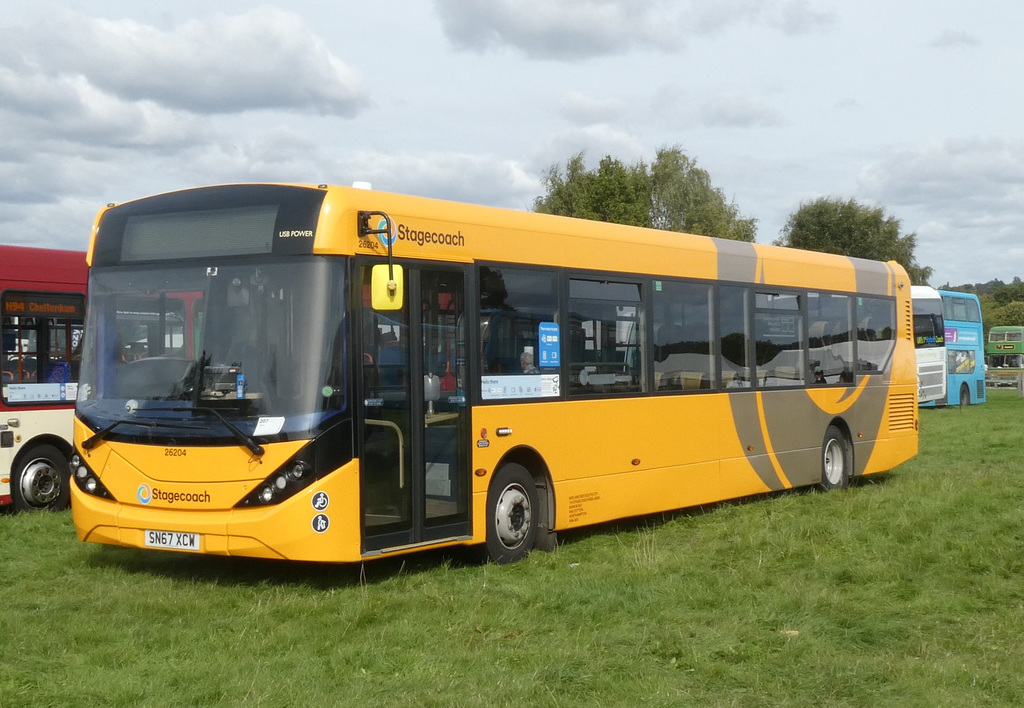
[0,0,1024,286]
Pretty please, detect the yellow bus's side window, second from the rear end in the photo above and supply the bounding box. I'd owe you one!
[807,293,853,384]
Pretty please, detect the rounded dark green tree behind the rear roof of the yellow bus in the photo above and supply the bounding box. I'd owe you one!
[774,197,932,285]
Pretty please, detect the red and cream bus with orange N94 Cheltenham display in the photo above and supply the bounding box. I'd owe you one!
[0,246,87,511]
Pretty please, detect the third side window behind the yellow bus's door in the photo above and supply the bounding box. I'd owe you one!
[651,281,715,390]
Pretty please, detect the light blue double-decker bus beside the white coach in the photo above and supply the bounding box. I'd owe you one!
[939,290,985,406]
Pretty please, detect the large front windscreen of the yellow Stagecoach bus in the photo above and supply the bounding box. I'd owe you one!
[78,258,347,438]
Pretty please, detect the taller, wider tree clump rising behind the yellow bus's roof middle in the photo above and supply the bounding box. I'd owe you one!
[534,147,757,241]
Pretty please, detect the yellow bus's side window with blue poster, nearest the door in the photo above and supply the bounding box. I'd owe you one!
[479,266,561,401]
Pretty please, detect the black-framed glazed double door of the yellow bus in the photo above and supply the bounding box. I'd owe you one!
[355,264,471,554]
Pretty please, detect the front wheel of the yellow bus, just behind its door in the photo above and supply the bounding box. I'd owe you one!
[487,463,540,564]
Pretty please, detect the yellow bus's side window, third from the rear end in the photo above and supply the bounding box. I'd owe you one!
[754,292,807,387]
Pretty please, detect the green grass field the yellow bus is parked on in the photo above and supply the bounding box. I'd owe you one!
[0,391,1024,707]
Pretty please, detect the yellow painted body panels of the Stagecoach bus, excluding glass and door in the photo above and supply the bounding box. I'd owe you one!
[72,186,918,561]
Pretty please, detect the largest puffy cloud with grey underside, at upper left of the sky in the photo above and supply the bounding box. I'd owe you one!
[7,7,368,117]
